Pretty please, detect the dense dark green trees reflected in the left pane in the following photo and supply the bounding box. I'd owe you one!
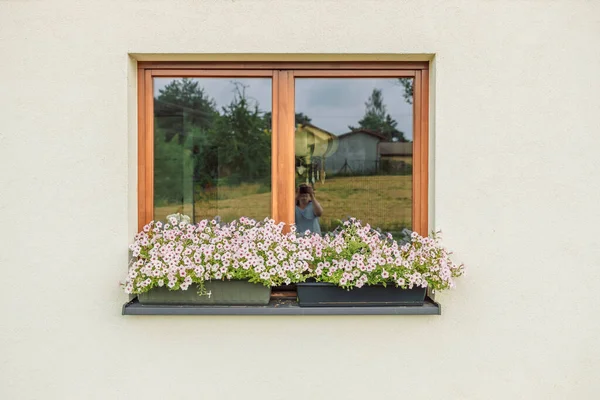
[154,78,271,205]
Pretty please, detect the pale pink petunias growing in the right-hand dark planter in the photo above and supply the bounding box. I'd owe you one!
[309,218,464,290]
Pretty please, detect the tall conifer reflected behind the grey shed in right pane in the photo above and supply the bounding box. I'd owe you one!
[348,89,407,142]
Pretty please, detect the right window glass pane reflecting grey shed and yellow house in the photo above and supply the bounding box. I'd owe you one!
[295,78,413,237]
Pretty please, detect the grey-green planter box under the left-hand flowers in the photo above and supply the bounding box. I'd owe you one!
[138,281,271,305]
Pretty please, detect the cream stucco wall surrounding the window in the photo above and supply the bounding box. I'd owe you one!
[0,0,600,399]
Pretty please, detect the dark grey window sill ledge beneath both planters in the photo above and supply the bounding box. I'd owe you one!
[123,297,442,315]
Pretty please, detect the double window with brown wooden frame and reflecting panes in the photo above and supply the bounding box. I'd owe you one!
[138,62,428,234]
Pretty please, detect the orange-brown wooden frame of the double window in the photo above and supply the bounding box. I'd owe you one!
[137,62,429,236]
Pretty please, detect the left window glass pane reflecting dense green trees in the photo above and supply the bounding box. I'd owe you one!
[154,78,272,222]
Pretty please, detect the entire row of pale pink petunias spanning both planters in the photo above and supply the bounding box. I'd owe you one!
[124,214,464,294]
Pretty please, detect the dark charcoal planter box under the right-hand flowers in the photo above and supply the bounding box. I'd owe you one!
[298,282,427,307]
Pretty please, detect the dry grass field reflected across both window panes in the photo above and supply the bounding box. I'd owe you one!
[155,175,412,232]
